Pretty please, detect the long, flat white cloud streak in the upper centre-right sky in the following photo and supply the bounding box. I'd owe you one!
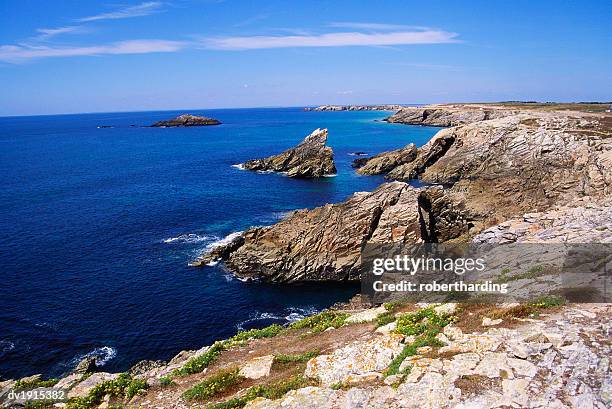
[203,30,459,50]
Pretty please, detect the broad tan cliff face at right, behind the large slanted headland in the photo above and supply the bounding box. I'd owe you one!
[388,112,612,227]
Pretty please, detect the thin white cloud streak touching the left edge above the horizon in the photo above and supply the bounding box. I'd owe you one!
[0,40,187,63]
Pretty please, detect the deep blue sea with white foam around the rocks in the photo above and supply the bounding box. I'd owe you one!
[0,108,438,378]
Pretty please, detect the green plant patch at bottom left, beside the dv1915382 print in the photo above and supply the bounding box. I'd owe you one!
[66,373,147,409]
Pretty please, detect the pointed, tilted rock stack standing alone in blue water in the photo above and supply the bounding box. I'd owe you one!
[242,129,336,178]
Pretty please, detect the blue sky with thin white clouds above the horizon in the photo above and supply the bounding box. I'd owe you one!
[0,0,612,116]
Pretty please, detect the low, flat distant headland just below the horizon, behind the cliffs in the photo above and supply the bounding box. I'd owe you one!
[385,105,518,126]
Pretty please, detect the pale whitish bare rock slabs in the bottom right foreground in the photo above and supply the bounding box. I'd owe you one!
[246,305,612,409]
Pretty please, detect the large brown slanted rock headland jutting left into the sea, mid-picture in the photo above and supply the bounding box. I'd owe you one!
[196,182,470,282]
